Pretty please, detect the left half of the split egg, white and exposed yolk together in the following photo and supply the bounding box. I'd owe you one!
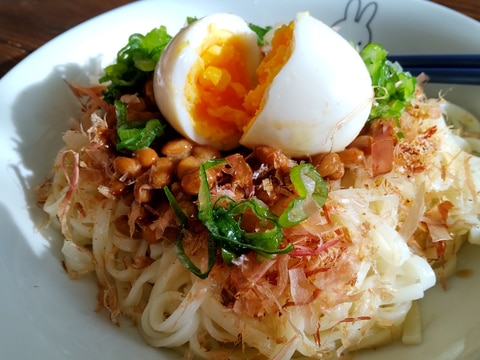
[154,13,261,150]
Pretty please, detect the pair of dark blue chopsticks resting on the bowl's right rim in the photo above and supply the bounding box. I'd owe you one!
[388,54,480,85]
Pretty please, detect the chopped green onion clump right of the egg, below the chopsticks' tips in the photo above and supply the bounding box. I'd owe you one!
[360,43,417,121]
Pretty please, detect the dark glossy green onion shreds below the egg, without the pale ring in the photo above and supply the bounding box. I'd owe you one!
[164,159,293,279]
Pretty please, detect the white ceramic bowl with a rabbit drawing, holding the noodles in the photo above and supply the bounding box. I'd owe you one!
[0,0,480,360]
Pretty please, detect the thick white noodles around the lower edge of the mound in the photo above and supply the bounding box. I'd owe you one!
[44,105,480,359]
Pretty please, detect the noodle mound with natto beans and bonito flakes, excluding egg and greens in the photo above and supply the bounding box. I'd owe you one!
[42,23,480,359]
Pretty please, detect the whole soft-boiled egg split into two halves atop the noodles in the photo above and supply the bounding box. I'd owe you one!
[154,12,373,157]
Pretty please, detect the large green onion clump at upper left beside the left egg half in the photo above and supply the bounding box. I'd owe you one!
[99,26,172,104]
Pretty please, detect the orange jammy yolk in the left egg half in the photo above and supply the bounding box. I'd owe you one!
[185,31,255,142]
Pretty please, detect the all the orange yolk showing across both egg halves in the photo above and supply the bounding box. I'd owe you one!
[185,23,293,144]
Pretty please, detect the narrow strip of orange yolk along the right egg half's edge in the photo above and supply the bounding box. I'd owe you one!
[244,22,294,120]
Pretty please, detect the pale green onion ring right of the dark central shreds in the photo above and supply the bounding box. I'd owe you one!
[279,163,328,227]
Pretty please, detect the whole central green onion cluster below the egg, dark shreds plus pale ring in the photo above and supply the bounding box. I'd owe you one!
[164,159,328,278]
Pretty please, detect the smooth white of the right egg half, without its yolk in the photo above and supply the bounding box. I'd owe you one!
[240,12,373,156]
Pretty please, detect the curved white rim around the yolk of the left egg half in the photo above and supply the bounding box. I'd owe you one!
[154,13,261,150]
